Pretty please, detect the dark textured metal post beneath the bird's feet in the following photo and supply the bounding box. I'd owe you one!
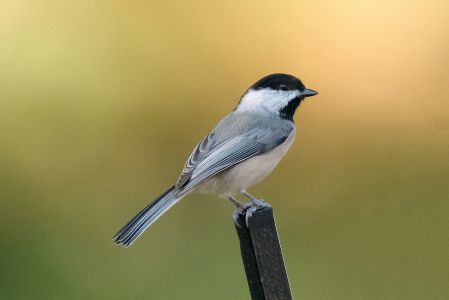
[235,207,293,300]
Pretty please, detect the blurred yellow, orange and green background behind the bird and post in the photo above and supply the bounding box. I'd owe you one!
[0,0,449,300]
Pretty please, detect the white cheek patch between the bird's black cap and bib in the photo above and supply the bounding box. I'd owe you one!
[236,88,300,114]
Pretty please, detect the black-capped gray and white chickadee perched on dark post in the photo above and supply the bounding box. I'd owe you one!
[112,73,318,247]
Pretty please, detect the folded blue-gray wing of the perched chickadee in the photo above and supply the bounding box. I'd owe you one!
[176,127,293,195]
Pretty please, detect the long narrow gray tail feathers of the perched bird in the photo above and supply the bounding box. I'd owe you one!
[112,186,183,247]
